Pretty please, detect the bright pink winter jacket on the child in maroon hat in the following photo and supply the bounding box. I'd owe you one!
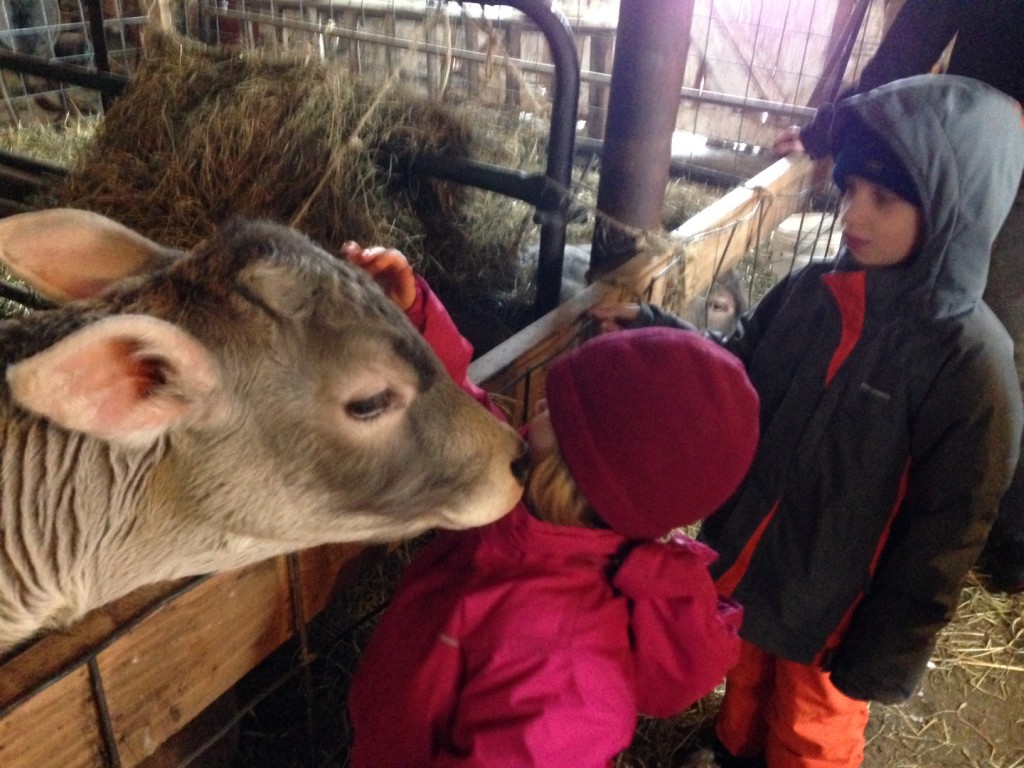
[348,276,740,768]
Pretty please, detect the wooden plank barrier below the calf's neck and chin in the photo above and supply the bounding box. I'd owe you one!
[0,545,368,768]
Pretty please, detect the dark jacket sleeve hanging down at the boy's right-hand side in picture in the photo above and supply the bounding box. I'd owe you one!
[830,331,1021,703]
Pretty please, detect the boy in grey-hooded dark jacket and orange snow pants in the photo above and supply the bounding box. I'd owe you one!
[595,75,1024,768]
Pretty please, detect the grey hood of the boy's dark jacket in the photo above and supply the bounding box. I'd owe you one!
[829,75,1024,318]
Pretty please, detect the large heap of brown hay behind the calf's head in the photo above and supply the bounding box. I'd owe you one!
[52,29,531,339]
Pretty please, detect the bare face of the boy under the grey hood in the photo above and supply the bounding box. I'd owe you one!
[839,173,922,267]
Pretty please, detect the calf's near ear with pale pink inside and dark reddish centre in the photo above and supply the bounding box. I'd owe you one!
[7,314,219,446]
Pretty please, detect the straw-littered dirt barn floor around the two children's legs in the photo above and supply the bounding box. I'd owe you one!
[233,542,1024,768]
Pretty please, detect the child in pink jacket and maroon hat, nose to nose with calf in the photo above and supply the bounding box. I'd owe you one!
[347,246,758,768]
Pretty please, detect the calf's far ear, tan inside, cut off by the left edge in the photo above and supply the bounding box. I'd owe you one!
[0,208,179,302]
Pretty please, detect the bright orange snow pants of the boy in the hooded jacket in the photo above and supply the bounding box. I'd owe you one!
[715,642,867,768]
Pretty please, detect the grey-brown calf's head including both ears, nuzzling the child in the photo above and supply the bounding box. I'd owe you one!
[0,210,521,548]
